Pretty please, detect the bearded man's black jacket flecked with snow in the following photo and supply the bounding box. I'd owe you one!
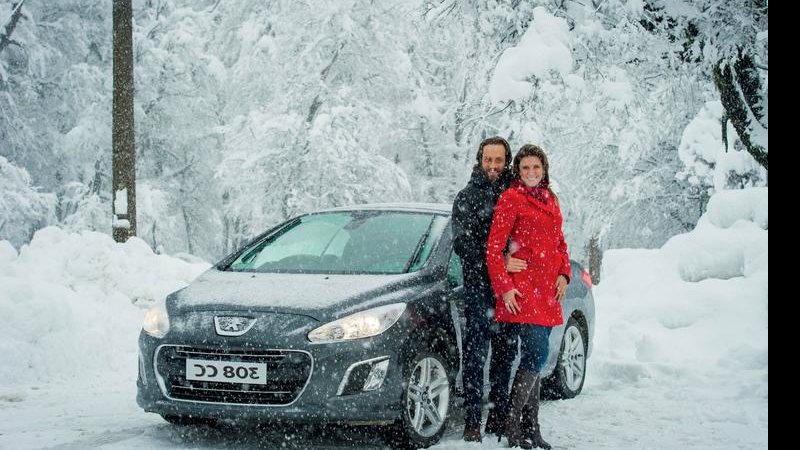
[453,167,511,289]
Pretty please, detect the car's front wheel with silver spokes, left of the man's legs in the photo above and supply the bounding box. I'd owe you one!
[386,350,454,448]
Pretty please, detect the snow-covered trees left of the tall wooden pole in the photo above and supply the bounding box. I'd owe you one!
[0,0,111,191]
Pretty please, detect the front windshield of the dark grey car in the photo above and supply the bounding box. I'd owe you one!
[227,211,447,274]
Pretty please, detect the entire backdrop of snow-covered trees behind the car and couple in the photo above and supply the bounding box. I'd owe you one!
[0,0,767,259]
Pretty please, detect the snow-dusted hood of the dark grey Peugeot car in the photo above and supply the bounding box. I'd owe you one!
[169,269,421,321]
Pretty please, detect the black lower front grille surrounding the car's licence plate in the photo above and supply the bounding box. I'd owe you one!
[156,346,312,406]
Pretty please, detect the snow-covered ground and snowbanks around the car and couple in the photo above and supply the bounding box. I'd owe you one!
[0,188,769,449]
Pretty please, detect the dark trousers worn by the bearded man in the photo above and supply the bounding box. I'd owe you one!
[462,286,517,426]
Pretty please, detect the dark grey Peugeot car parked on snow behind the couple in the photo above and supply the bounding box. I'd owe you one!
[137,204,594,448]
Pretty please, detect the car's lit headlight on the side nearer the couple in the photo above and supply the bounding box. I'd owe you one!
[308,303,406,344]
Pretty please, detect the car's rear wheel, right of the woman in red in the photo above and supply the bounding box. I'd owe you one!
[541,317,588,400]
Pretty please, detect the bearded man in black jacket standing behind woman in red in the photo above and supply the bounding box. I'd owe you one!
[453,136,525,442]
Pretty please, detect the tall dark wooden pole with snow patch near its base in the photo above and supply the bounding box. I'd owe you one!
[111,0,136,242]
